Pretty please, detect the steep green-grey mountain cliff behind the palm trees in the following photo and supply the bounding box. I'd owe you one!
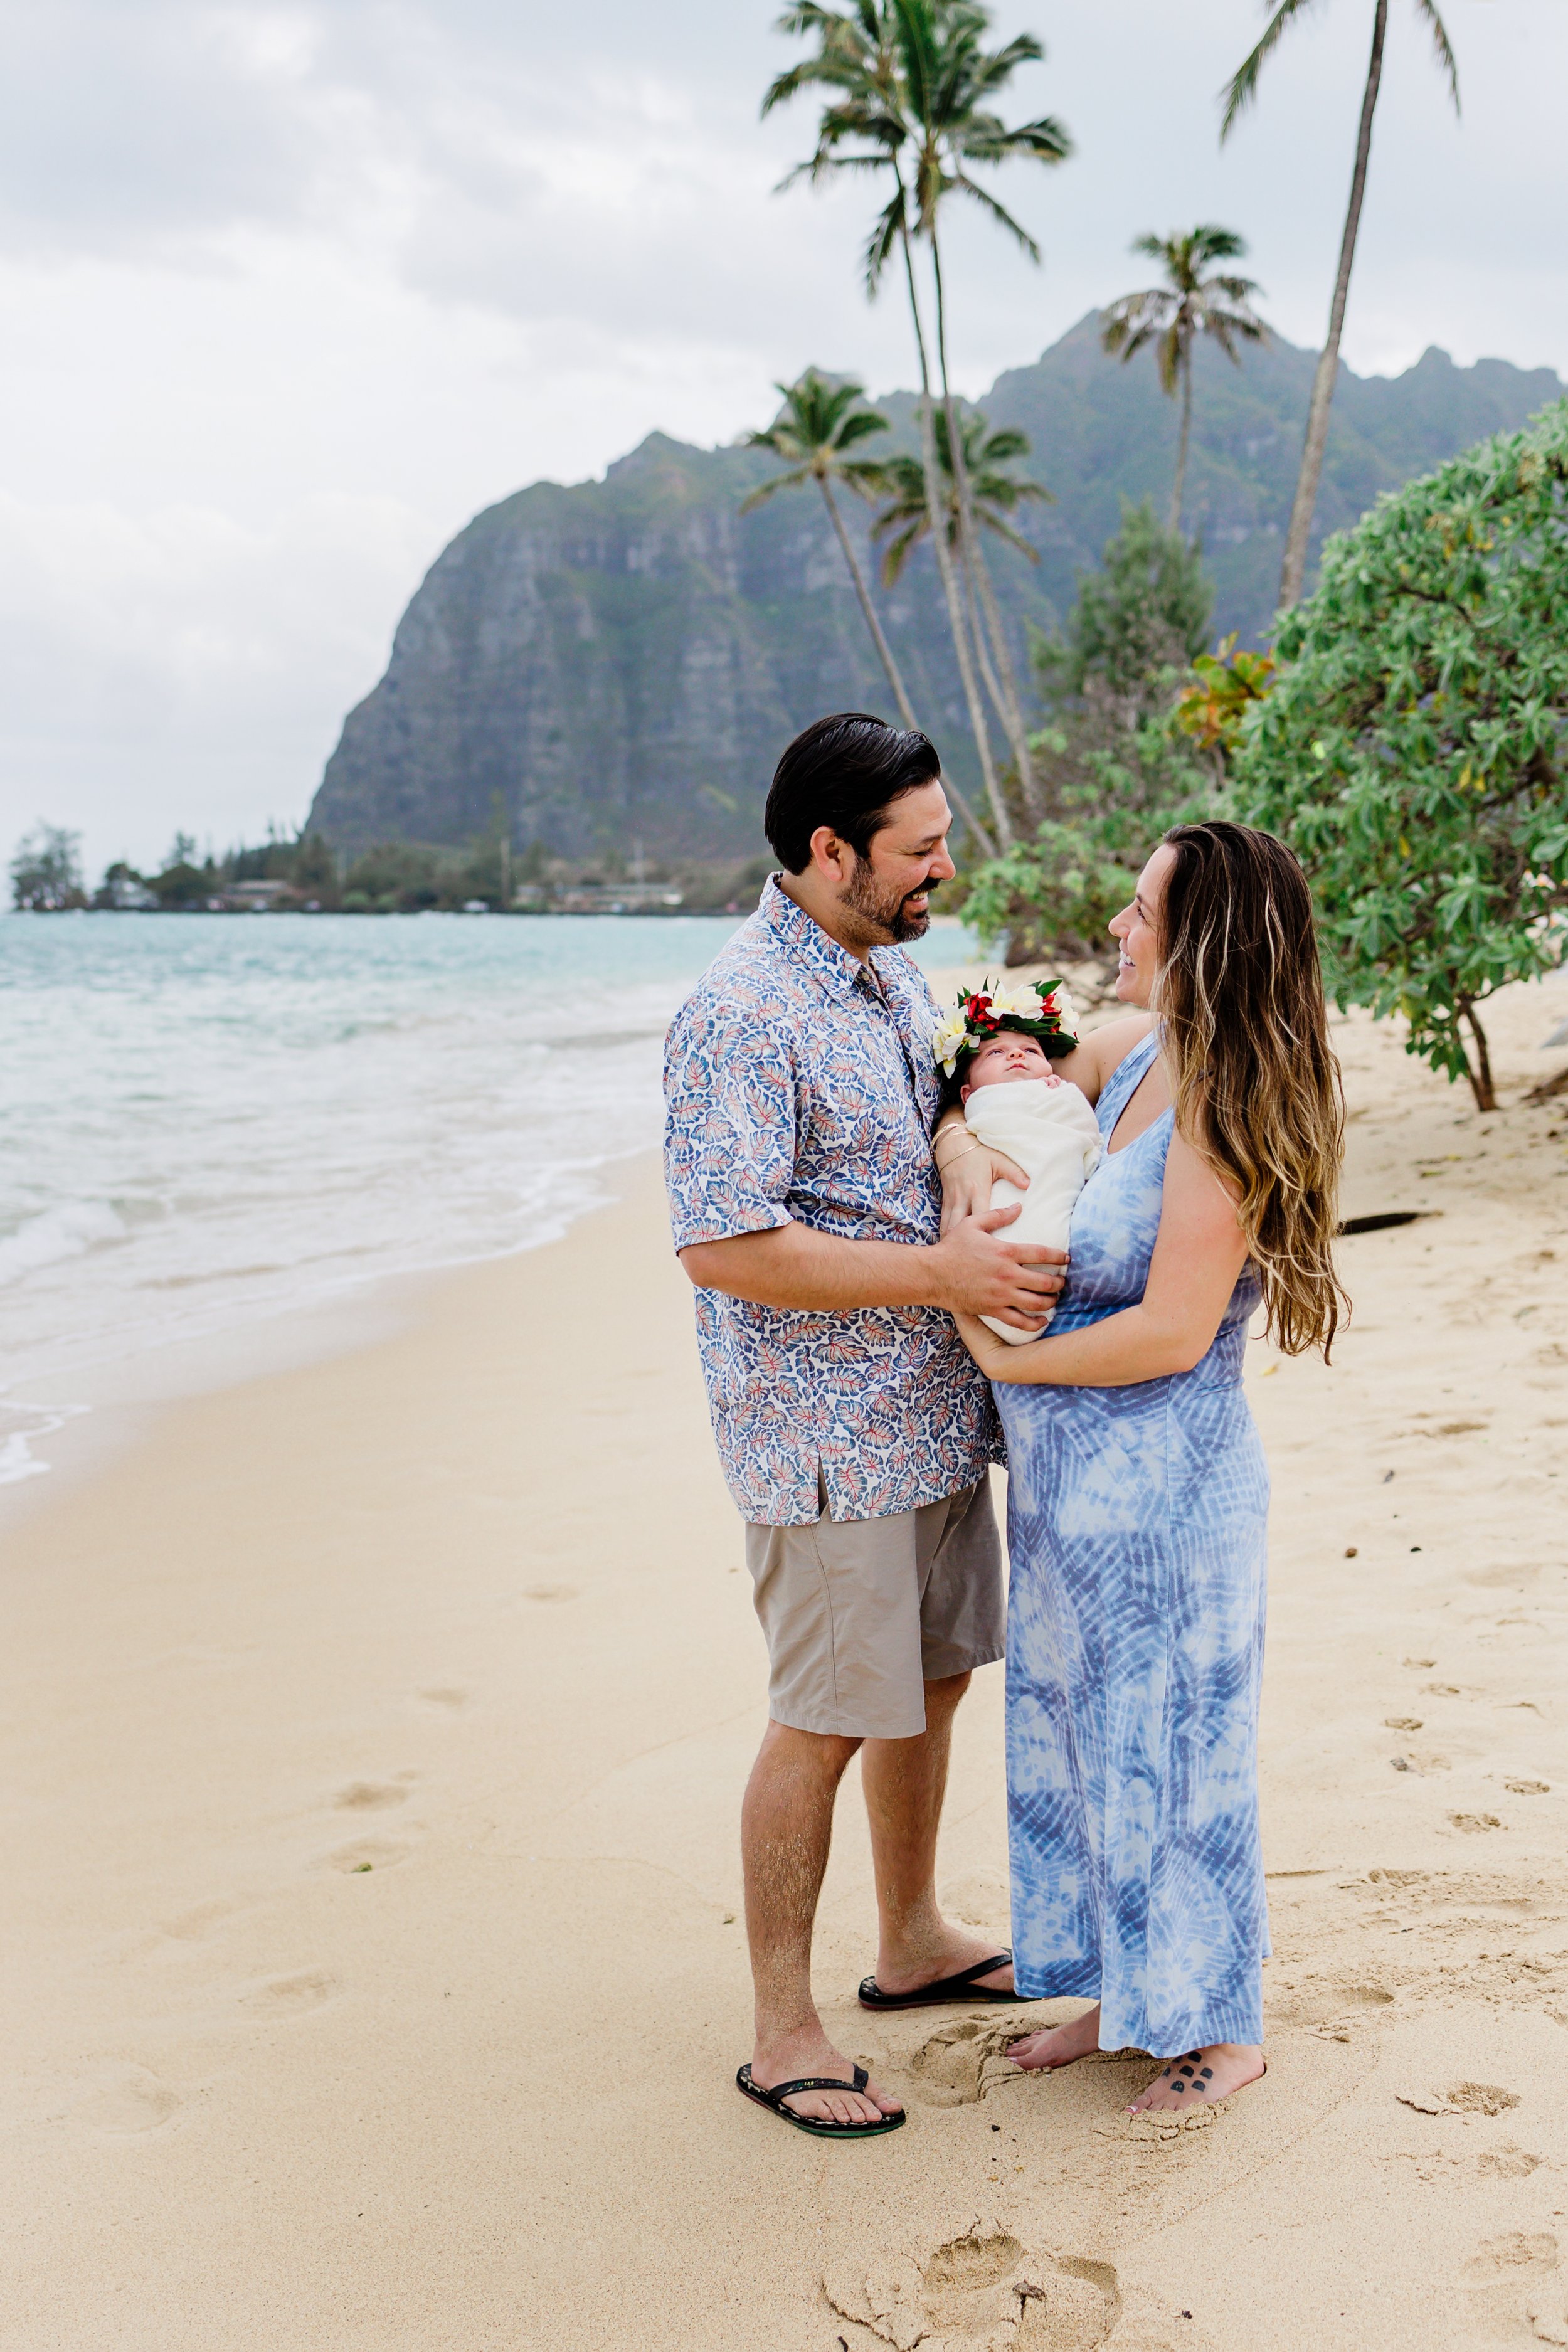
[308,315,1564,861]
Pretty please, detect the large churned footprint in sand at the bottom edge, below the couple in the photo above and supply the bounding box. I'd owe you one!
[823,2223,1121,2352]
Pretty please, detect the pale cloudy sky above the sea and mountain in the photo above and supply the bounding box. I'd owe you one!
[0,0,1568,875]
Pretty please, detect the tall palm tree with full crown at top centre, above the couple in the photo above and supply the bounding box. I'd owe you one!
[761,0,1067,842]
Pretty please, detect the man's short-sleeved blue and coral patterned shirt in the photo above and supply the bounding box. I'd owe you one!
[665,880,1002,1527]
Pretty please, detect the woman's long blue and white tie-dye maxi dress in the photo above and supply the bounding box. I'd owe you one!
[997,1037,1269,2058]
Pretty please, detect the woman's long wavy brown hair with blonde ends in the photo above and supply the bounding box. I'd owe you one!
[1154,824,1349,1357]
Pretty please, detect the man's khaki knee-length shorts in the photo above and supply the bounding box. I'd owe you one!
[745,1480,1006,1740]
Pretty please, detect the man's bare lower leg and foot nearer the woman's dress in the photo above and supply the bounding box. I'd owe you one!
[861,1675,1013,1992]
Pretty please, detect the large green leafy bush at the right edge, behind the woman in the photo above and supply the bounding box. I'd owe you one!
[1234,402,1568,1110]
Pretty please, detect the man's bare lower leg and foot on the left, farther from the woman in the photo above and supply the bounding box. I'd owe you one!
[741,1724,901,2124]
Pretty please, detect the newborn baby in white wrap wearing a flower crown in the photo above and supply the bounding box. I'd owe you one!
[938,988,1100,1348]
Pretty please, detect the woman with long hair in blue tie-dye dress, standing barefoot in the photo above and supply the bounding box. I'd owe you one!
[938,824,1345,2112]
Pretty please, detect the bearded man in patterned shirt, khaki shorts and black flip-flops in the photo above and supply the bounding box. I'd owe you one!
[665,712,1062,2138]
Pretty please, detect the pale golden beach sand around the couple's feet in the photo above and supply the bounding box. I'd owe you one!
[0,964,1568,2352]
